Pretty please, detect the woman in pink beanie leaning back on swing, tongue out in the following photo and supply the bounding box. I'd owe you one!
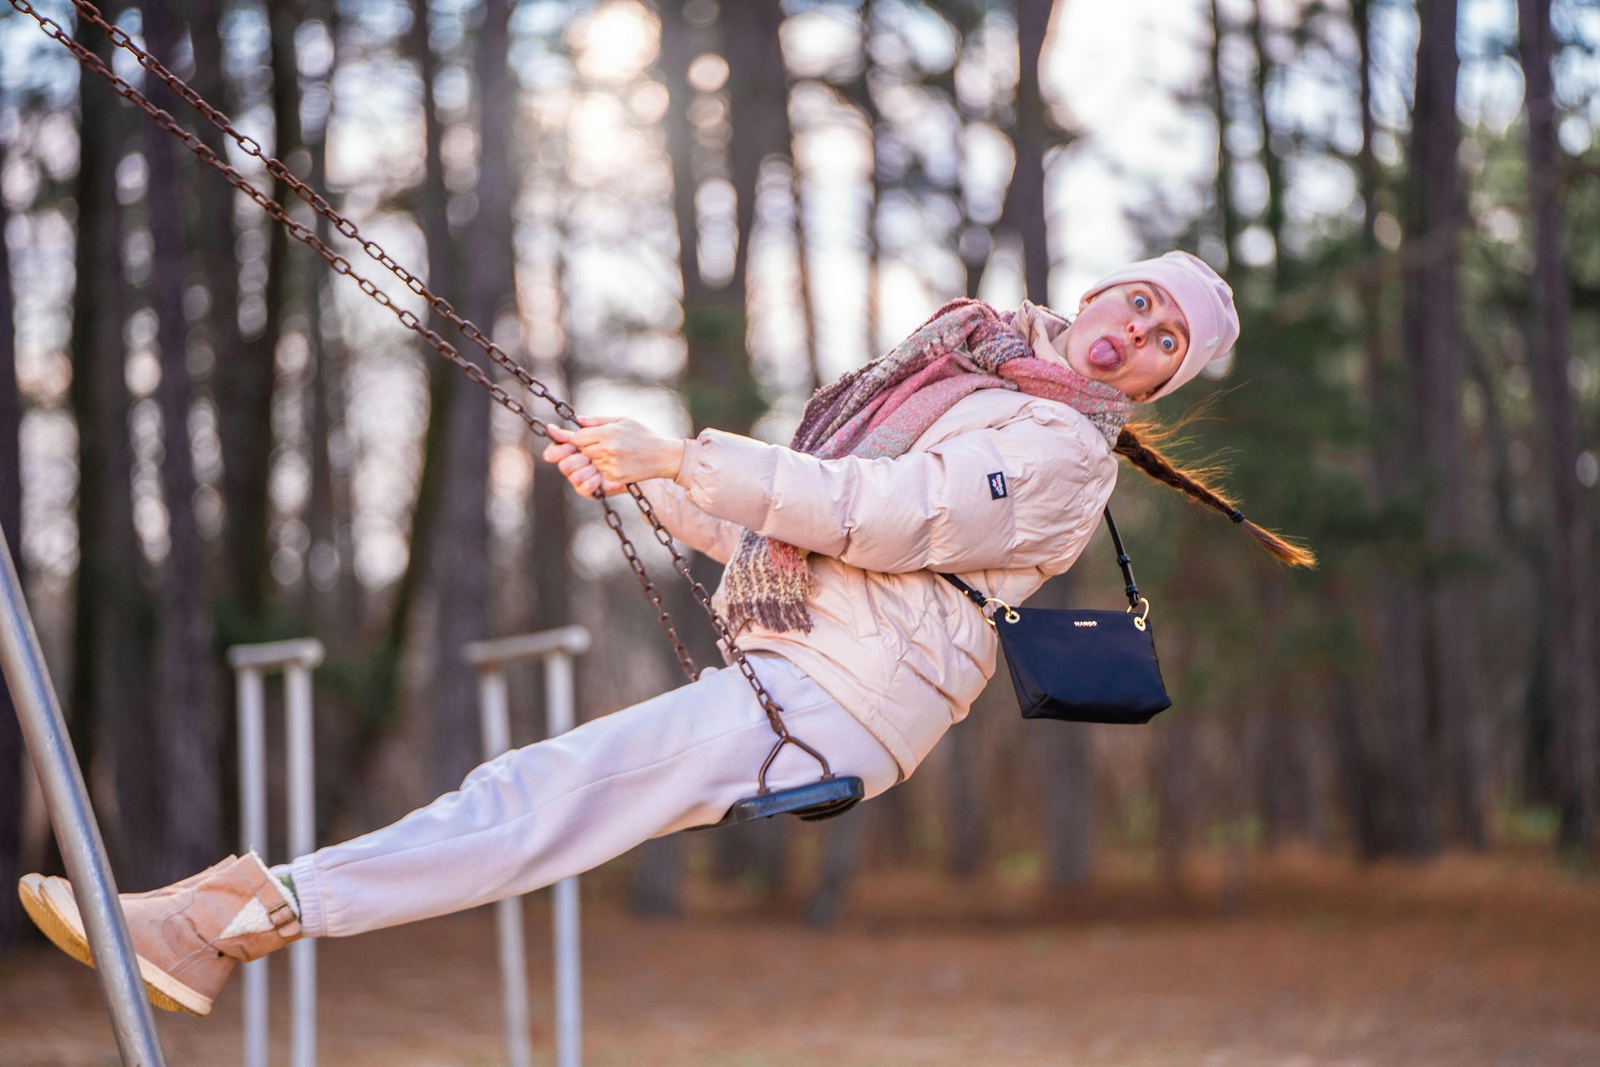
[19,251,1310,1014]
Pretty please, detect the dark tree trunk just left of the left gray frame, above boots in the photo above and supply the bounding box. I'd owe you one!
[144,0,222,881]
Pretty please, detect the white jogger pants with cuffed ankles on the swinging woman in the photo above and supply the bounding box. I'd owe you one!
[290,654,899,937]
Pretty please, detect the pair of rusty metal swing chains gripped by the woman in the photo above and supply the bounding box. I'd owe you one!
[10,0,832,764]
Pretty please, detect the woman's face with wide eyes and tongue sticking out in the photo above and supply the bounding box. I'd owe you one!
[1066,282,1189,400]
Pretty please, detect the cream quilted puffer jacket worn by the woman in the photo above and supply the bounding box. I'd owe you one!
[642,389,1117,777]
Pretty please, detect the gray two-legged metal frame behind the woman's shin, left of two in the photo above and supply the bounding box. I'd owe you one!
[227,638,323,1067]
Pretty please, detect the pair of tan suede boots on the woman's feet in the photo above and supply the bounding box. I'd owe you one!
[18,853,301,1016]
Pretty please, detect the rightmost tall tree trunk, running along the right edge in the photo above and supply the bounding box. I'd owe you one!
[1517,0,1600,849]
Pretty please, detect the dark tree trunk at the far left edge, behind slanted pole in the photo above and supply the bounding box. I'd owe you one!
[0,141,24,952]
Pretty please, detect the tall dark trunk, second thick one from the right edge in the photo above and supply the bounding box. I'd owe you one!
[1405,0,1488,848]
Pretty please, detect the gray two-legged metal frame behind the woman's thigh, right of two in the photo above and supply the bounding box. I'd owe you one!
[462,625,589,1067]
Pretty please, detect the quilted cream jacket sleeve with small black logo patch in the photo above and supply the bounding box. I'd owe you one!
[677,405,1117,573]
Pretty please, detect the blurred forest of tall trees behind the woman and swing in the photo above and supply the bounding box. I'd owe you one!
[0,0,1600,959]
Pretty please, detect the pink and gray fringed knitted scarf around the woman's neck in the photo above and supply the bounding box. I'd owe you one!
[717,299,1133,633]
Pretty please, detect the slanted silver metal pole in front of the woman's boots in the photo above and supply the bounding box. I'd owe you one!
[0,531,166,1067]
